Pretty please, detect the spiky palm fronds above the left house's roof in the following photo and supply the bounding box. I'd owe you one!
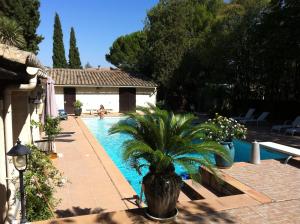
[0,16,26,48]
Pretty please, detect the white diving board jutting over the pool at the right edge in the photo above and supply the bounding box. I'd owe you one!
[259,142,300,164]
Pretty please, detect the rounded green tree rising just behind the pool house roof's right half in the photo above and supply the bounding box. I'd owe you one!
[105,31,146,73]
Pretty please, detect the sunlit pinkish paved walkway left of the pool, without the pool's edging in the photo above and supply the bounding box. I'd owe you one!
[54,117,133,218]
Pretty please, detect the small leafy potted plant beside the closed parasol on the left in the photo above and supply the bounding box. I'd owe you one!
[44,117,61,153]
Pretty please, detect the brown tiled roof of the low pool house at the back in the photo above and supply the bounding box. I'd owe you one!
[47,68,157,87]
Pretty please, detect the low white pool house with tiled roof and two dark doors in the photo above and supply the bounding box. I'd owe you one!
[47,68,157,113]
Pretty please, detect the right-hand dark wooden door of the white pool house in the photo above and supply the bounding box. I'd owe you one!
[119,88,136,113]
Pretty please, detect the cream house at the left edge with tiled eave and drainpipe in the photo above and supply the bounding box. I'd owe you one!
[0,44,47,223]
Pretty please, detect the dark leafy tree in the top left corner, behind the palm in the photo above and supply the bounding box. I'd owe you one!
[0,0,43,53]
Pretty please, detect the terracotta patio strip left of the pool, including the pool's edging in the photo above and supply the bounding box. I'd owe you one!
[49,116,136,217]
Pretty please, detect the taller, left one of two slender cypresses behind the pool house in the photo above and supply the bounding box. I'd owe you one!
[52,13,68,68]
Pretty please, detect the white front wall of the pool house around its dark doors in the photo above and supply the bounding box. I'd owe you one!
[55,86,156,113]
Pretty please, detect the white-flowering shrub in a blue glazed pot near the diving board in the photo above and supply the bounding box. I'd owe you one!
[206,114,247,168]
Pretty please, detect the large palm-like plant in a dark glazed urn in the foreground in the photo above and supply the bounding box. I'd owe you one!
[109,105,228,220]
